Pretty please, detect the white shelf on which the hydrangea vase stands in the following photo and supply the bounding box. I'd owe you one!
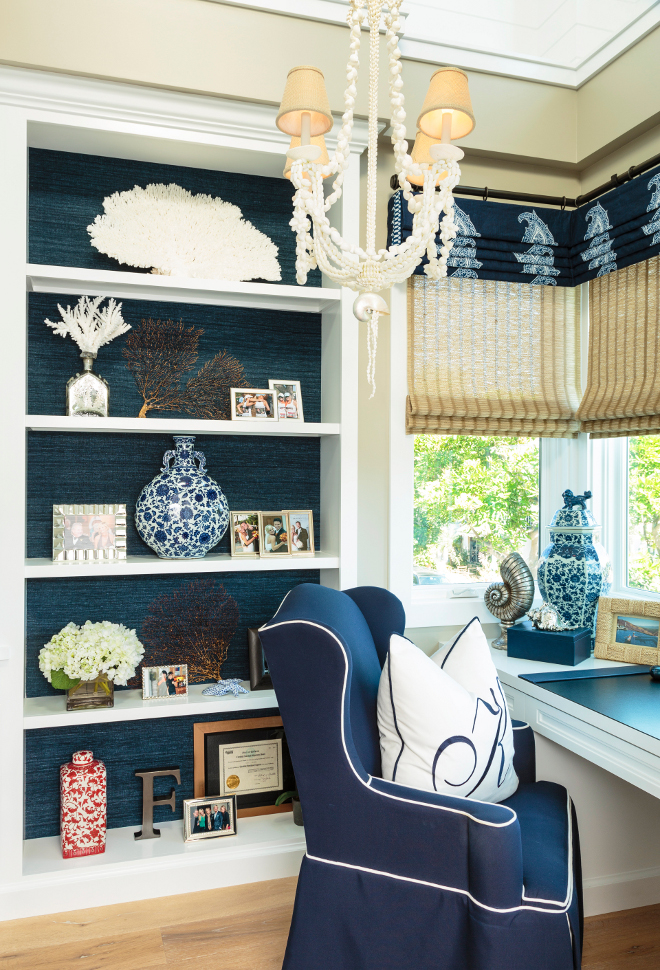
[23,680,277,731]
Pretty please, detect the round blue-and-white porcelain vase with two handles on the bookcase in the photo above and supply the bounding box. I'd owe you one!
[135,435,229,559]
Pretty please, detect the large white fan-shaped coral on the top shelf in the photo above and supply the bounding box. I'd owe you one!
[87,183,282,280]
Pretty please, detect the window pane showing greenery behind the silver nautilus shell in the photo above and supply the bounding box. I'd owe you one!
[413,434,540,586]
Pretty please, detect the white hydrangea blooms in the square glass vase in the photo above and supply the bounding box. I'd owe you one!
[39,620,144,690]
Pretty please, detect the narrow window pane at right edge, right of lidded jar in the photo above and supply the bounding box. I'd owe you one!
[628,435,660,593]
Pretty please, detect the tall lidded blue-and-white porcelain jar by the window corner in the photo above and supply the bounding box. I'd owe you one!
[537,489,612,641]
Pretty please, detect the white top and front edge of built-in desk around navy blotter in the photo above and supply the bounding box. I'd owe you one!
[491,648,660,798]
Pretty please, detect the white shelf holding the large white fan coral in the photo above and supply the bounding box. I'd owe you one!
[26,263,341,313]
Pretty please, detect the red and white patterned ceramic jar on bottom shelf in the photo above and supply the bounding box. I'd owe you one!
[60,751,106,859]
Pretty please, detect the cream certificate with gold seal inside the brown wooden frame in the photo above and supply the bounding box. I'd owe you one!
[218,738,284,795]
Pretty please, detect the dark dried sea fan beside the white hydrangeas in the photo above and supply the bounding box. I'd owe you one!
[130,579,240,683]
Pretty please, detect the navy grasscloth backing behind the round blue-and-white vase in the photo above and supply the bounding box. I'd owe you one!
[27,428,322,558]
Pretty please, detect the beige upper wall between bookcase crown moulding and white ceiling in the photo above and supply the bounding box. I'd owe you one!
[0,0,636,165]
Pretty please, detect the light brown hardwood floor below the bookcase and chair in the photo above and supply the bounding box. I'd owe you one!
[0,878,660,970]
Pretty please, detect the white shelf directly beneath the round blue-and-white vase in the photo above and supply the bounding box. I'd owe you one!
[25,552,339,579]
